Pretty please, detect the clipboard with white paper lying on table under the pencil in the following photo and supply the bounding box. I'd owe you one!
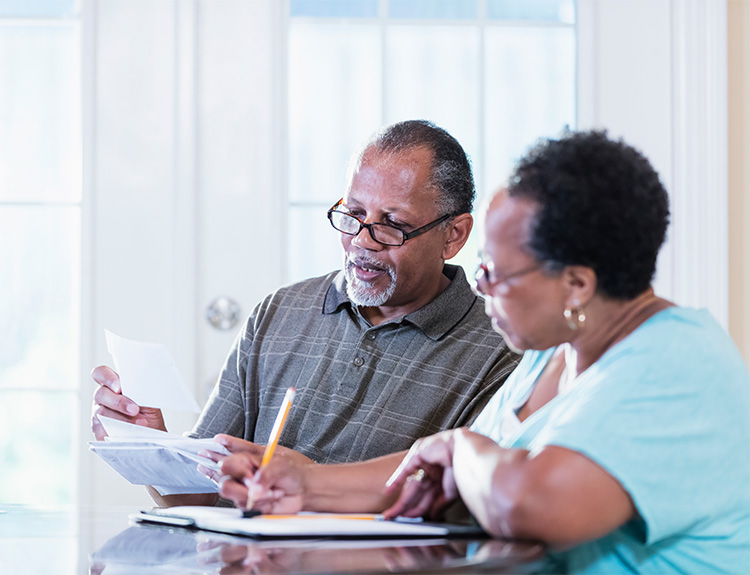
[130,506,487,539]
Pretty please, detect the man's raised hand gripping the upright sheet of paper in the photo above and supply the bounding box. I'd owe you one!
[91,365,167,441]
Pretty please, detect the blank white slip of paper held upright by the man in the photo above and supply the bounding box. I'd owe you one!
[105,330,200,413]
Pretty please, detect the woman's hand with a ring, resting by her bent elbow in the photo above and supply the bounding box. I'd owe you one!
[383,429,461,518]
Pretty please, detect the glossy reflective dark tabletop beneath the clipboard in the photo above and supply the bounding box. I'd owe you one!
[0,505,544,575]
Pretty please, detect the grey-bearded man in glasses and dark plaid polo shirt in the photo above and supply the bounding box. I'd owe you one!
[92,121,517,504]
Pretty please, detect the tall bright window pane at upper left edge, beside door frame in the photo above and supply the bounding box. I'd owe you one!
[0,24,82,202]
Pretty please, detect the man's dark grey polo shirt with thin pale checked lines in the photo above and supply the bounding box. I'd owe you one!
[190,265,518,463]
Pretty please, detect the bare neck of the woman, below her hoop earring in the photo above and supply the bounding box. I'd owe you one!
[566,288,674,376]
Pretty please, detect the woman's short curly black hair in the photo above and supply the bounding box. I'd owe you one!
[508,131,669,299]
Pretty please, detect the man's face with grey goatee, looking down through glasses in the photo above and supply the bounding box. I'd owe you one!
[341,148,448,317]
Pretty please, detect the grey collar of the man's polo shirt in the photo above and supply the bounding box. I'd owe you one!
[323,264,477,340]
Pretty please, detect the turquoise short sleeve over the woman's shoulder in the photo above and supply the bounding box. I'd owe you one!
[530,316,750,544]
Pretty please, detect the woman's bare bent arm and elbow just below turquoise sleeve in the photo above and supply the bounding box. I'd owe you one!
[453,429,637,547]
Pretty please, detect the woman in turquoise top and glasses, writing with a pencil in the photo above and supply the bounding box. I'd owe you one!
[216,132,750,573]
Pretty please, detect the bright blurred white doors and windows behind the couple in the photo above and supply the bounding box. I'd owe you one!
[0,0,750,516]
